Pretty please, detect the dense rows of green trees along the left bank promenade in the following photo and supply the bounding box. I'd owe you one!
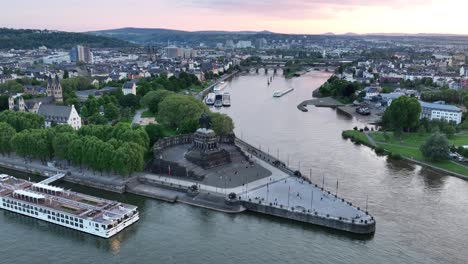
[0,113,150,176]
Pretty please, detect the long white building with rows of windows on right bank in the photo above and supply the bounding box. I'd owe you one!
[419,101,463,125]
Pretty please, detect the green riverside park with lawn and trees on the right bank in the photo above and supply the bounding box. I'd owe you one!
[342,96,468,176]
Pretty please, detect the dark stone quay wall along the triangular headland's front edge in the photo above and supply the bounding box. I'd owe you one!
[242,201,375,234]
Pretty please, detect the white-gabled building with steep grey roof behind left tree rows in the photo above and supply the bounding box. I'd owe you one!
[37,104,81,130]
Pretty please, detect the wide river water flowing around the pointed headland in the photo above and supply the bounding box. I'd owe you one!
[0,72,468,264]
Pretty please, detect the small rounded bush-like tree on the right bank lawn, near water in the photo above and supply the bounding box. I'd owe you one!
[420,133,450,161]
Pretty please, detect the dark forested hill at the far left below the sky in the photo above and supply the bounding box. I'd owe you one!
[0,28,133,49]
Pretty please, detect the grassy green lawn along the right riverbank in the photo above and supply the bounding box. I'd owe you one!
[371,132,468,176]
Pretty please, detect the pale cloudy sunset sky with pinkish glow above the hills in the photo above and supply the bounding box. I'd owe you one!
[0,0,468,34]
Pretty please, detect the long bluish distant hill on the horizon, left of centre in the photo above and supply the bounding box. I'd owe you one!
[86,28,275,44]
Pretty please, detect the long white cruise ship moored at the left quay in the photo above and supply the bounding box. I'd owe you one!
[0,174,139,238]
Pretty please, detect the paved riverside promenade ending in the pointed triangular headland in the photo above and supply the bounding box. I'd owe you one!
[0,139,376,234]
